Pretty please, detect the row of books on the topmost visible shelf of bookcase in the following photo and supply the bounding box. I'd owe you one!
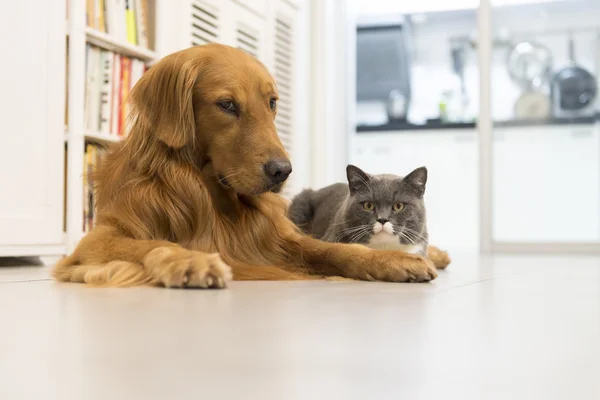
[86,0,149,48]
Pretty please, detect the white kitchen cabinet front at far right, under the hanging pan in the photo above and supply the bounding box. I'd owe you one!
[493,125,600,243]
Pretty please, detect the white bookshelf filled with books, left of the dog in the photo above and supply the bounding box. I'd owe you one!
[64,0,161,251]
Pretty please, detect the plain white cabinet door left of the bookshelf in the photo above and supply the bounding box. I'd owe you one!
[0,0,65,245]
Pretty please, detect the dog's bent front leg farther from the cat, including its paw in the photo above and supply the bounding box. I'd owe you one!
[53,225,231,288]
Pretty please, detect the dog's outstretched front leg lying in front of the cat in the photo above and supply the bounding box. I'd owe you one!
[294,234,437,282]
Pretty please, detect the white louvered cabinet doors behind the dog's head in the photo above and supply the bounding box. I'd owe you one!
[178,0,308,197]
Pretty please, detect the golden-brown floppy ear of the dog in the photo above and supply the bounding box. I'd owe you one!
[128,54,199,148]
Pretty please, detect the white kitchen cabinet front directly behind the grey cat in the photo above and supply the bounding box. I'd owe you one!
[349,129,479,250]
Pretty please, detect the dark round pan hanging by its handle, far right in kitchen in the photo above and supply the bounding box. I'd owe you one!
[552,36,598,118]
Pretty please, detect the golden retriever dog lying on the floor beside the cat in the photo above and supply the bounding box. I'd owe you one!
[54,44,449,288]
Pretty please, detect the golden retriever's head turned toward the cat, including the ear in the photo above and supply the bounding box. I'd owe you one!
[129,44,292,195]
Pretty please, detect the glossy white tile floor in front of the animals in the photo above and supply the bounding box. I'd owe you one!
[0,254,600,400]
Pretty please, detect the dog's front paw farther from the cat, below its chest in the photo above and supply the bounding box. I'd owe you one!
[144,247,232,289]
